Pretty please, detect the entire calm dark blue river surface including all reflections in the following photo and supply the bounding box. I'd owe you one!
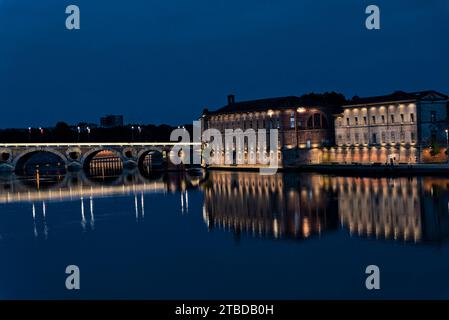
[0,171,449,299]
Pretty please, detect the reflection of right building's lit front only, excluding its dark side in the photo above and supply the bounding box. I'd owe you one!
[335,177,422,242]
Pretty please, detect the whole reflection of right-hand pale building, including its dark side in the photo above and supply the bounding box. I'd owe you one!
[335,177,449,242]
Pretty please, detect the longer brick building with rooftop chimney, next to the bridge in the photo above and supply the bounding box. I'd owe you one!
[201,93,345,167]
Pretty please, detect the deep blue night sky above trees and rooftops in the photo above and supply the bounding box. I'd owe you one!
[0,0,449,127]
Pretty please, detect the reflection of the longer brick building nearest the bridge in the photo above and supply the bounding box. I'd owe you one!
[203,172,338,238]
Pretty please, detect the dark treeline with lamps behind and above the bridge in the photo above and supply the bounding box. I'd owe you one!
[0,122,175,143]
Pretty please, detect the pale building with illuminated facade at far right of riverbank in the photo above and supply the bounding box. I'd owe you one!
[327,91,448,164]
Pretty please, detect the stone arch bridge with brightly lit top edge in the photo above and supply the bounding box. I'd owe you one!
[0,142,199,171]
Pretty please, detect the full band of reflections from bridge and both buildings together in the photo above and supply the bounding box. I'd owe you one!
[0,170,449,243]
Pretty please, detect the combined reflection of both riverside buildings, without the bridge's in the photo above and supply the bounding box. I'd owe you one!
[203,172,449,243]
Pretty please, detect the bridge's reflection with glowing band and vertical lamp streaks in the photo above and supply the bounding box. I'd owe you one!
[0,169,201,239]
